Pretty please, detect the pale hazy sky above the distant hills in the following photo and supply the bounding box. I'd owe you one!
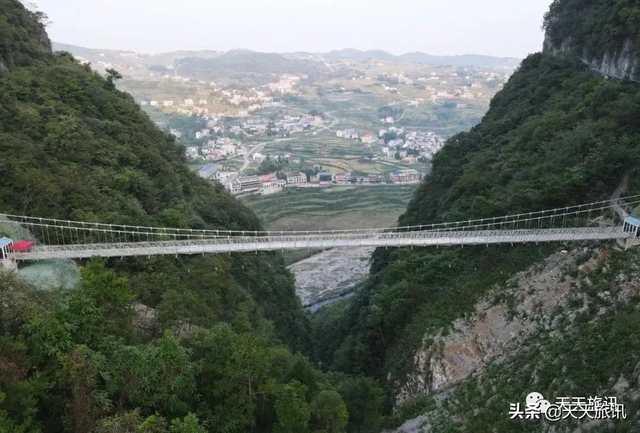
[25,0,551,57]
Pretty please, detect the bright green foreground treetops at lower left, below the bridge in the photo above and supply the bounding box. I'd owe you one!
[0,260,383,433]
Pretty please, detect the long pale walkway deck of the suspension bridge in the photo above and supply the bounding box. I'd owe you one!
[12,227,629,260]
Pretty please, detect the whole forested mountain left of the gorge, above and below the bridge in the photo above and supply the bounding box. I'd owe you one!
[0,0,383,433]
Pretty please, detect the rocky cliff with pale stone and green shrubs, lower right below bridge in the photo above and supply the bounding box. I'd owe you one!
[396,247,640,433]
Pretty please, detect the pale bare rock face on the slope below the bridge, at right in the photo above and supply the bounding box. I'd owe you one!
[395,246,609,405]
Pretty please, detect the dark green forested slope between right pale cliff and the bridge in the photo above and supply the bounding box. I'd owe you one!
[400,54,640,224]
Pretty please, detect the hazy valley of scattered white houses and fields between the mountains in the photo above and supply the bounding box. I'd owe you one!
[67,49,510,201]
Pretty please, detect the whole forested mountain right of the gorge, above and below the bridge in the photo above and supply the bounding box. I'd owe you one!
[316,0,640,431]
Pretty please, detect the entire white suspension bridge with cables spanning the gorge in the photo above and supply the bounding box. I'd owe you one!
[0,195,640,261]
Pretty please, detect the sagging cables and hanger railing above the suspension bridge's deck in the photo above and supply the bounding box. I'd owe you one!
[0,195,640,247]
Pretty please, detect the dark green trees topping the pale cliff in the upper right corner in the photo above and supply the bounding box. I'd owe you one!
[544,0,640,76]
